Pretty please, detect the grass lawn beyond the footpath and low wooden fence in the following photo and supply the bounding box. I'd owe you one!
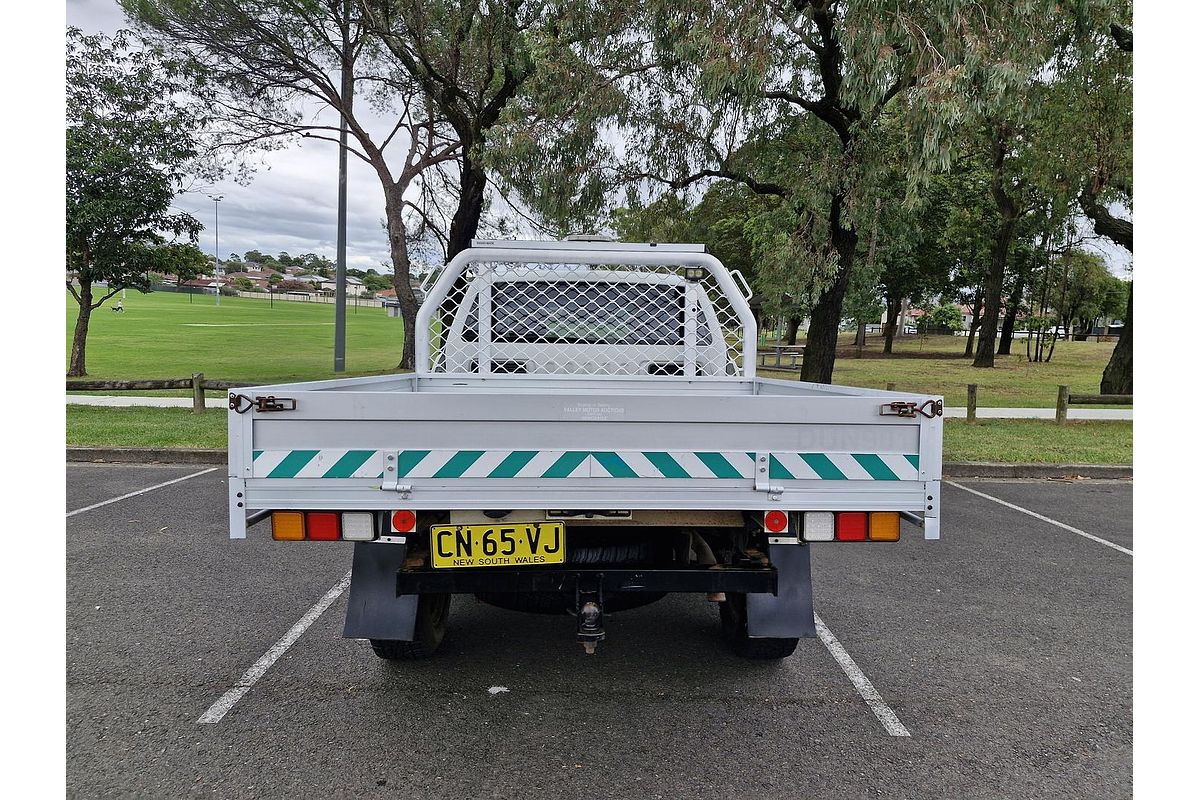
[64,291,1114,408]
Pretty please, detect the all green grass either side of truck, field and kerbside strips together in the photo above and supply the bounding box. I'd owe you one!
[66,291,1133,463]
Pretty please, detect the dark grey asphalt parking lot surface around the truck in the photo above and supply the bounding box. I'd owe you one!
[66,464,1134,798]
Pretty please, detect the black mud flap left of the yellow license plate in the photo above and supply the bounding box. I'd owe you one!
[342,542,416,642]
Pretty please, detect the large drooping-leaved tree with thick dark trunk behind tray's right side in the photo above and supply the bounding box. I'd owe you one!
[595,0,1044,383]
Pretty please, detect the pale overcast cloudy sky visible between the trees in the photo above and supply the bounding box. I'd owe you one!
[67,0,1132,277]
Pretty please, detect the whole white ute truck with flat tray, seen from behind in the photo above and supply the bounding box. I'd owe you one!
[229,239,942,660]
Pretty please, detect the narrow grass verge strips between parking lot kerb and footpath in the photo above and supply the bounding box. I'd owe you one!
[67,405,1133,464]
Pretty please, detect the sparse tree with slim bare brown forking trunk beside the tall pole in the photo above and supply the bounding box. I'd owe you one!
[121,0,463,368]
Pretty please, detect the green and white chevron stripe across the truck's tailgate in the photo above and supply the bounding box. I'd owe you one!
[253,449,918,481]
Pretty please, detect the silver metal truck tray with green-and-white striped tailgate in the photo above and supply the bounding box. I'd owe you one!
[229,374,942,539]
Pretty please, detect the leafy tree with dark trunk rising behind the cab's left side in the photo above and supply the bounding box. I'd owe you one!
[359,0,641,251]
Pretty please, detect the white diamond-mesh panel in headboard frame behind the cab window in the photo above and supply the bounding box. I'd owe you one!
[428,261,745,378]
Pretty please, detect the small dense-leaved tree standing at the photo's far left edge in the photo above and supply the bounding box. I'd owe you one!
[66,28,212,377]
